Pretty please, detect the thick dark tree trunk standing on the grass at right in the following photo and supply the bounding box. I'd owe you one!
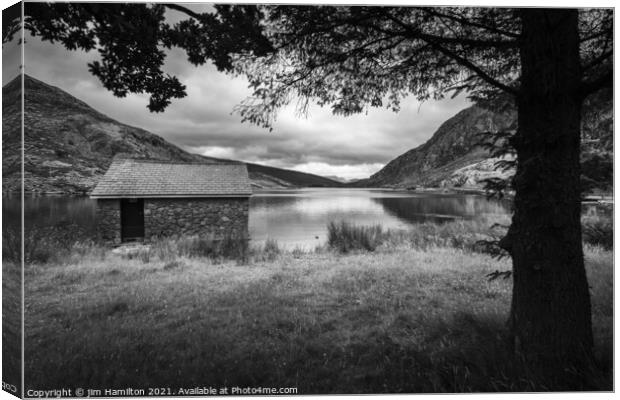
[502,8,593,375]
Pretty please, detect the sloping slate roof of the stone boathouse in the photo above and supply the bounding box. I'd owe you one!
[90,158,252,198]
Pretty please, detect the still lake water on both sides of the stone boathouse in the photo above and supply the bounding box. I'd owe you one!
[2,188,509,249]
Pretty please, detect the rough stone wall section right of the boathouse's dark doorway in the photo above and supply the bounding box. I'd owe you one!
[144,198,250,240]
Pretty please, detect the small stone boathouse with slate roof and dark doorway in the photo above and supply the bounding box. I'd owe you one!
[90,158,252,244]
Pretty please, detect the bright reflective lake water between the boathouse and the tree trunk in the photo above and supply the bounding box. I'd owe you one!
[250,189,509,248]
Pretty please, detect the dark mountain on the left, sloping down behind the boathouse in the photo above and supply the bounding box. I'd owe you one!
[2,75,340,193]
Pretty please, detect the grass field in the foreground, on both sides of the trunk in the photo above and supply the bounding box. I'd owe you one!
[25,222,613,394]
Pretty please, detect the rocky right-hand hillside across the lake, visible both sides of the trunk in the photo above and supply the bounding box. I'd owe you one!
[353,99,613,193]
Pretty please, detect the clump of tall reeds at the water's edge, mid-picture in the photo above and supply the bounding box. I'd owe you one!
[327,221,383,253]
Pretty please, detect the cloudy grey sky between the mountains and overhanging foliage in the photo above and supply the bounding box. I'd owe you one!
[2,5,468,179]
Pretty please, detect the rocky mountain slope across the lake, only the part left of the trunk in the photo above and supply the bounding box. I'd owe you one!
[355,106,516,188]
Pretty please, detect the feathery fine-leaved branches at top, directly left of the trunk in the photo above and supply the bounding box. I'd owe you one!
[229,6,518,126]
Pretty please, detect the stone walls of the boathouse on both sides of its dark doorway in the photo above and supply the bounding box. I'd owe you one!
[97,197,250,244]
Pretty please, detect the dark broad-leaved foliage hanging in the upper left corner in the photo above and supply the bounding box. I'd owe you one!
[3,3,269,112]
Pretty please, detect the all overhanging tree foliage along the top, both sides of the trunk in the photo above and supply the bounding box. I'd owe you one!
[3,3,613,117]
